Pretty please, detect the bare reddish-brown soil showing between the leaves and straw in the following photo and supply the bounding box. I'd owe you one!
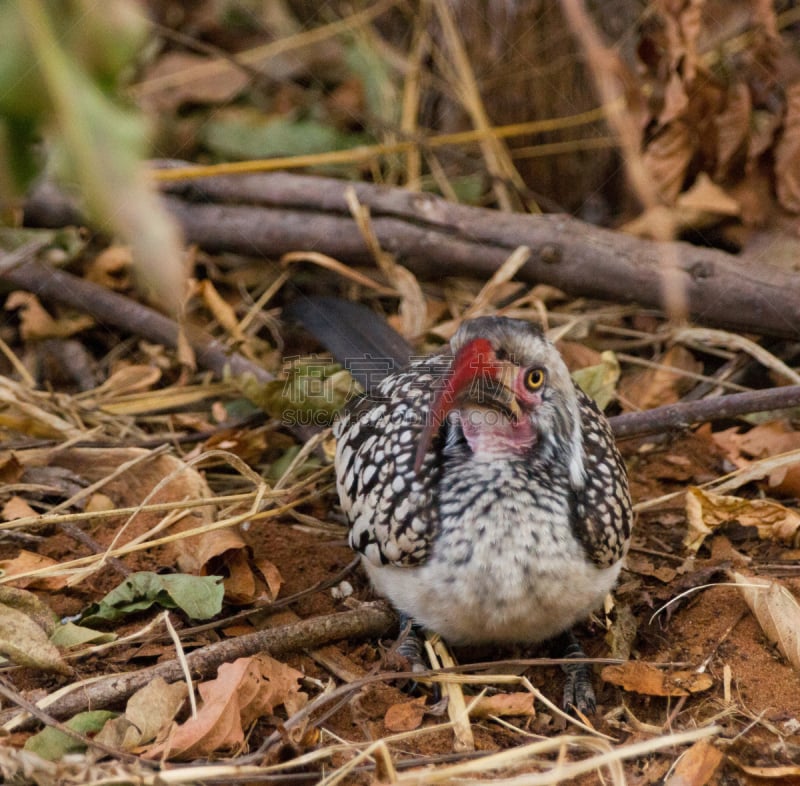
[7,422,800,784]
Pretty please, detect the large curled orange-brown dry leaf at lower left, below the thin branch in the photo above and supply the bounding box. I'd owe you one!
[146,655,303,761]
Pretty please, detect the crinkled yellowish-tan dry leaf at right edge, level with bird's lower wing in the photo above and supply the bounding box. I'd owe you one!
[683,487,800,551]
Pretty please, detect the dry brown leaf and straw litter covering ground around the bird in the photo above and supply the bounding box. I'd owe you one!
[0,4,800,784]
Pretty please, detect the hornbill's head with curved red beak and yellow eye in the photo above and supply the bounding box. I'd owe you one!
[416,317,583,487]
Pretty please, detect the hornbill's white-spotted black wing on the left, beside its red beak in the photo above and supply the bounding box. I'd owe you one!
[334,356,452,565]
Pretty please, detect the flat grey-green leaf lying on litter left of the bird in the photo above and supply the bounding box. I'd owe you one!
[81,571,224,625]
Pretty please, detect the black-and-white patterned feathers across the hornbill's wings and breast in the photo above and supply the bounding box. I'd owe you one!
[335,339,631,567]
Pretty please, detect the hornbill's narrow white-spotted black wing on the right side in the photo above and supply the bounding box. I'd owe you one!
[575,386,633,567]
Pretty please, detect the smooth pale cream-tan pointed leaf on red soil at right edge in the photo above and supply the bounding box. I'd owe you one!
[731,572,800,671]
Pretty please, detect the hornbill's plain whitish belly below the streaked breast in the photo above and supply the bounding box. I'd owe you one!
[363,508,621,644]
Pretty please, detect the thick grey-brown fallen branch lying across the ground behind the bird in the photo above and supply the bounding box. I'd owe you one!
[25,167,800,338]
